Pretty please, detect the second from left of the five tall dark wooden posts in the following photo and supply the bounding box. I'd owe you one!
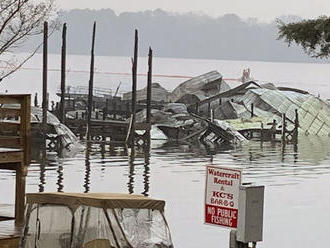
[60,23,66,123]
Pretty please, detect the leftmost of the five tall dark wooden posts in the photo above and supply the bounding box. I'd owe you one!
[42,22,48,138]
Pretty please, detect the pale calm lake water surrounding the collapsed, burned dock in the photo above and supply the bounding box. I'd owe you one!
[0,55,330,248]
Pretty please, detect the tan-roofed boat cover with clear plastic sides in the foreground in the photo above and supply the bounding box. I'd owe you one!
[20,193,173,248]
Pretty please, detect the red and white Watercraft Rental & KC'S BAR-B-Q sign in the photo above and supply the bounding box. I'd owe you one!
[205,166,242,228]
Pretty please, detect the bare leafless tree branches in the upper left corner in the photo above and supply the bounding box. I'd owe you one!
[0,0,56,81]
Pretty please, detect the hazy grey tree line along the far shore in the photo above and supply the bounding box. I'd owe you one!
[18,9,324,62]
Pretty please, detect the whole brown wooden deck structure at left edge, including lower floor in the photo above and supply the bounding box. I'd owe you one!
[0,95,31,248]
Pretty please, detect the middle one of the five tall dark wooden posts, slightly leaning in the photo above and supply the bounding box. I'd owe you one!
[87,22,96,140]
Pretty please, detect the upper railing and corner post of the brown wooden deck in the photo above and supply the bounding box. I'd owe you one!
[0,95,31,224]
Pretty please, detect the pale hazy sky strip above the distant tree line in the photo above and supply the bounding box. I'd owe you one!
[57,0,330,21]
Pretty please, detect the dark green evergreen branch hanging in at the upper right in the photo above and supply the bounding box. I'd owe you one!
[277,16,330,58]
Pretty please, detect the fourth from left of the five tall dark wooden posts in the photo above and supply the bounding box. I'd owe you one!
[130,30,138,145]
